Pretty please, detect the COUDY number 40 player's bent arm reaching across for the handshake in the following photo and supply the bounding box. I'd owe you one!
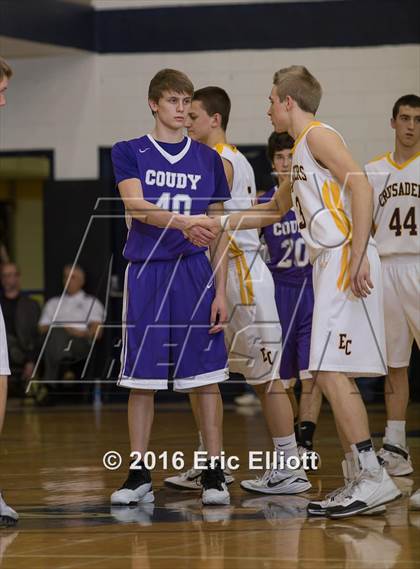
[118,178,213,239]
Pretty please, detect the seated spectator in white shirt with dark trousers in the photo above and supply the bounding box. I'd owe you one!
[39,265,104,382]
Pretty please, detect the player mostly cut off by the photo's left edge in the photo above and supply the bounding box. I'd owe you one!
[0,58,19,526]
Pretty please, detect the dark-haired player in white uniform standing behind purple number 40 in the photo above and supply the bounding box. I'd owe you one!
[165,86,311,494]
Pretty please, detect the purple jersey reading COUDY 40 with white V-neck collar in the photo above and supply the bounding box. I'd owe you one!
[111,135,230,262]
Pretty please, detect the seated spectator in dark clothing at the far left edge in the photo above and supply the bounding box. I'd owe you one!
[0,262,40,381]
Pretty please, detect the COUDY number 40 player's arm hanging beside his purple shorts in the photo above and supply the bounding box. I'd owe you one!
[208,203,229,334]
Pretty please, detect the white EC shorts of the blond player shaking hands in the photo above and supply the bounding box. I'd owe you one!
[309,245,387,378]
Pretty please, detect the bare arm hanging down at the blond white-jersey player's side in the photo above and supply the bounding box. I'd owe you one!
[307,128,373,297]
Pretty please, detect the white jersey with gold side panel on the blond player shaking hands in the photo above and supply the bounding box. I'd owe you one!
[291,121,352,262]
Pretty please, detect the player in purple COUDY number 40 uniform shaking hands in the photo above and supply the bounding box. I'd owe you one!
[111,69,230,504]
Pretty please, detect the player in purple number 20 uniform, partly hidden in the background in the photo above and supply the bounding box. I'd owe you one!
[259,132,322,454]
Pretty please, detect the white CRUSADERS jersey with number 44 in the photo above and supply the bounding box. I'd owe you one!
[365,152,420,257]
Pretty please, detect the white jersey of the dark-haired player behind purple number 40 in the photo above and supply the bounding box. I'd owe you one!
[214,144,261,256]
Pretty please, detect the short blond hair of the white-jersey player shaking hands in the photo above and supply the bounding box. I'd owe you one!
[273,65,322,114]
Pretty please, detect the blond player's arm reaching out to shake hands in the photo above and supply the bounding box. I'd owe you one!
[184,180,292,246]
